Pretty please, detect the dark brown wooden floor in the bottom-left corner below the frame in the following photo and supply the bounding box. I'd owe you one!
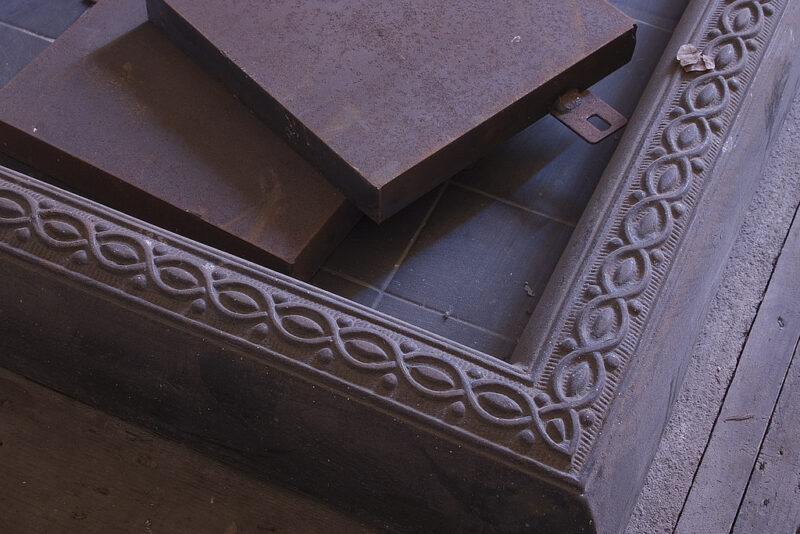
[0,370,372,534]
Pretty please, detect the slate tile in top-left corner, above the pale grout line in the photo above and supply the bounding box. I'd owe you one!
[0,0,94,39]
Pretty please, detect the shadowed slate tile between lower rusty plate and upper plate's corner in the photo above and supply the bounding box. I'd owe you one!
[324,189,439,288]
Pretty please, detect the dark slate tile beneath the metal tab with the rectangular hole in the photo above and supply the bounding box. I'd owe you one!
[454,25,669,224]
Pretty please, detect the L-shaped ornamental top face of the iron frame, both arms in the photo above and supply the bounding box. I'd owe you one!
[0,0,788,532]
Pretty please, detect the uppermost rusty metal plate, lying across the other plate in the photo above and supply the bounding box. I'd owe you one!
[148,0,635,221]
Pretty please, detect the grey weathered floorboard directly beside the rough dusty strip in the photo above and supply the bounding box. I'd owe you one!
[676,207,800,534]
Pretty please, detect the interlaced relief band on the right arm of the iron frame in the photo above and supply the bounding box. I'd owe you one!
[536,0,785,473]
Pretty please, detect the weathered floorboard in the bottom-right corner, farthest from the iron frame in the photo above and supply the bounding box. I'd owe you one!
[733,344,800,534]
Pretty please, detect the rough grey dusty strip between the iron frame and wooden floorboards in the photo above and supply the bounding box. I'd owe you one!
[626,88,800,534]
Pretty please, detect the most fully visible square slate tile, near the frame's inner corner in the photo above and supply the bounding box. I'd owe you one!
[387,185,572,339]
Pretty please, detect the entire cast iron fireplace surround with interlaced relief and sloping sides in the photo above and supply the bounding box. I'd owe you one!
[0,0,800,532]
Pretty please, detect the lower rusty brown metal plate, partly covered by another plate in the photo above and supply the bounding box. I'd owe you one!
[0,0,360,277]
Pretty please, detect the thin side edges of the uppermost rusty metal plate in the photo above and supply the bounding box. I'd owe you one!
[147,0,636,223]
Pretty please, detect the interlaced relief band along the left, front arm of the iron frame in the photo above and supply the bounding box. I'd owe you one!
[0,179,576,474]
